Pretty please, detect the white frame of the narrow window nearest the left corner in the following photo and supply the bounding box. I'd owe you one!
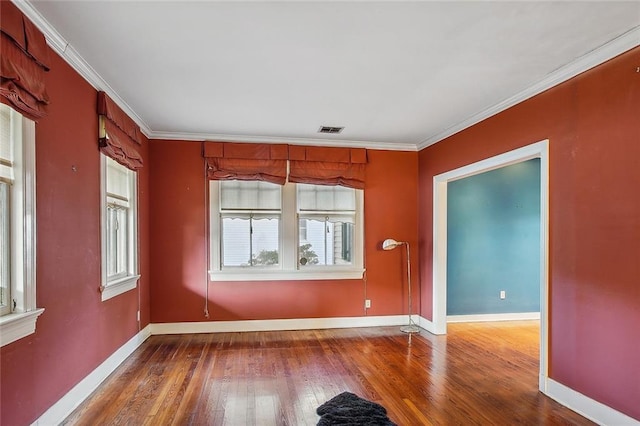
[100,153,140,302]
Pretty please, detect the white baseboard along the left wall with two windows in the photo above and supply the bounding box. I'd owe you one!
[32,326,151,426]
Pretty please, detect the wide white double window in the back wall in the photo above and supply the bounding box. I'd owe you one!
[209,181,364,281]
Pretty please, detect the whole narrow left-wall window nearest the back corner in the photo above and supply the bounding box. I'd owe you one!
[101,154,140,300]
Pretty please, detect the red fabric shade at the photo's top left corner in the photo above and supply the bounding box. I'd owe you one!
[0,1,49,120]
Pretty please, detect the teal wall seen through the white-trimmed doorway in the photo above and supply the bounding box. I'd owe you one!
[447,158,540,315]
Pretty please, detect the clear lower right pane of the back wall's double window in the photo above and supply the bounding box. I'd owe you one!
[298,218,354,266]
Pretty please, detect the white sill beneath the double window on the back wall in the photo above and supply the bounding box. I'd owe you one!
[209,269,364,281]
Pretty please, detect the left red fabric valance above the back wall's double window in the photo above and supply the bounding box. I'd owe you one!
[203,142,288,185]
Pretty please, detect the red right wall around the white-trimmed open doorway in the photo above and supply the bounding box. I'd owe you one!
[419,48,640,419]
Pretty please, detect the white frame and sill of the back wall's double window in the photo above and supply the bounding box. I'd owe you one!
[208,180,364,281]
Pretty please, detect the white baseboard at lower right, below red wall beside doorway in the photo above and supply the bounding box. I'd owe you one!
[545,379,640,426]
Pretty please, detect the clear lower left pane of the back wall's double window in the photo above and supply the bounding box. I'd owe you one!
[222,216,280,266]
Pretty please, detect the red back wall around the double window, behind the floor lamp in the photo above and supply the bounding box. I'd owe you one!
[150,140,418,323]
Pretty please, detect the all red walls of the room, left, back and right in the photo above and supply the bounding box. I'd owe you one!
[0,6,640,425]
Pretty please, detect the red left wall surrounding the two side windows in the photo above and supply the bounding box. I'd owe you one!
[0,52,149,425]
